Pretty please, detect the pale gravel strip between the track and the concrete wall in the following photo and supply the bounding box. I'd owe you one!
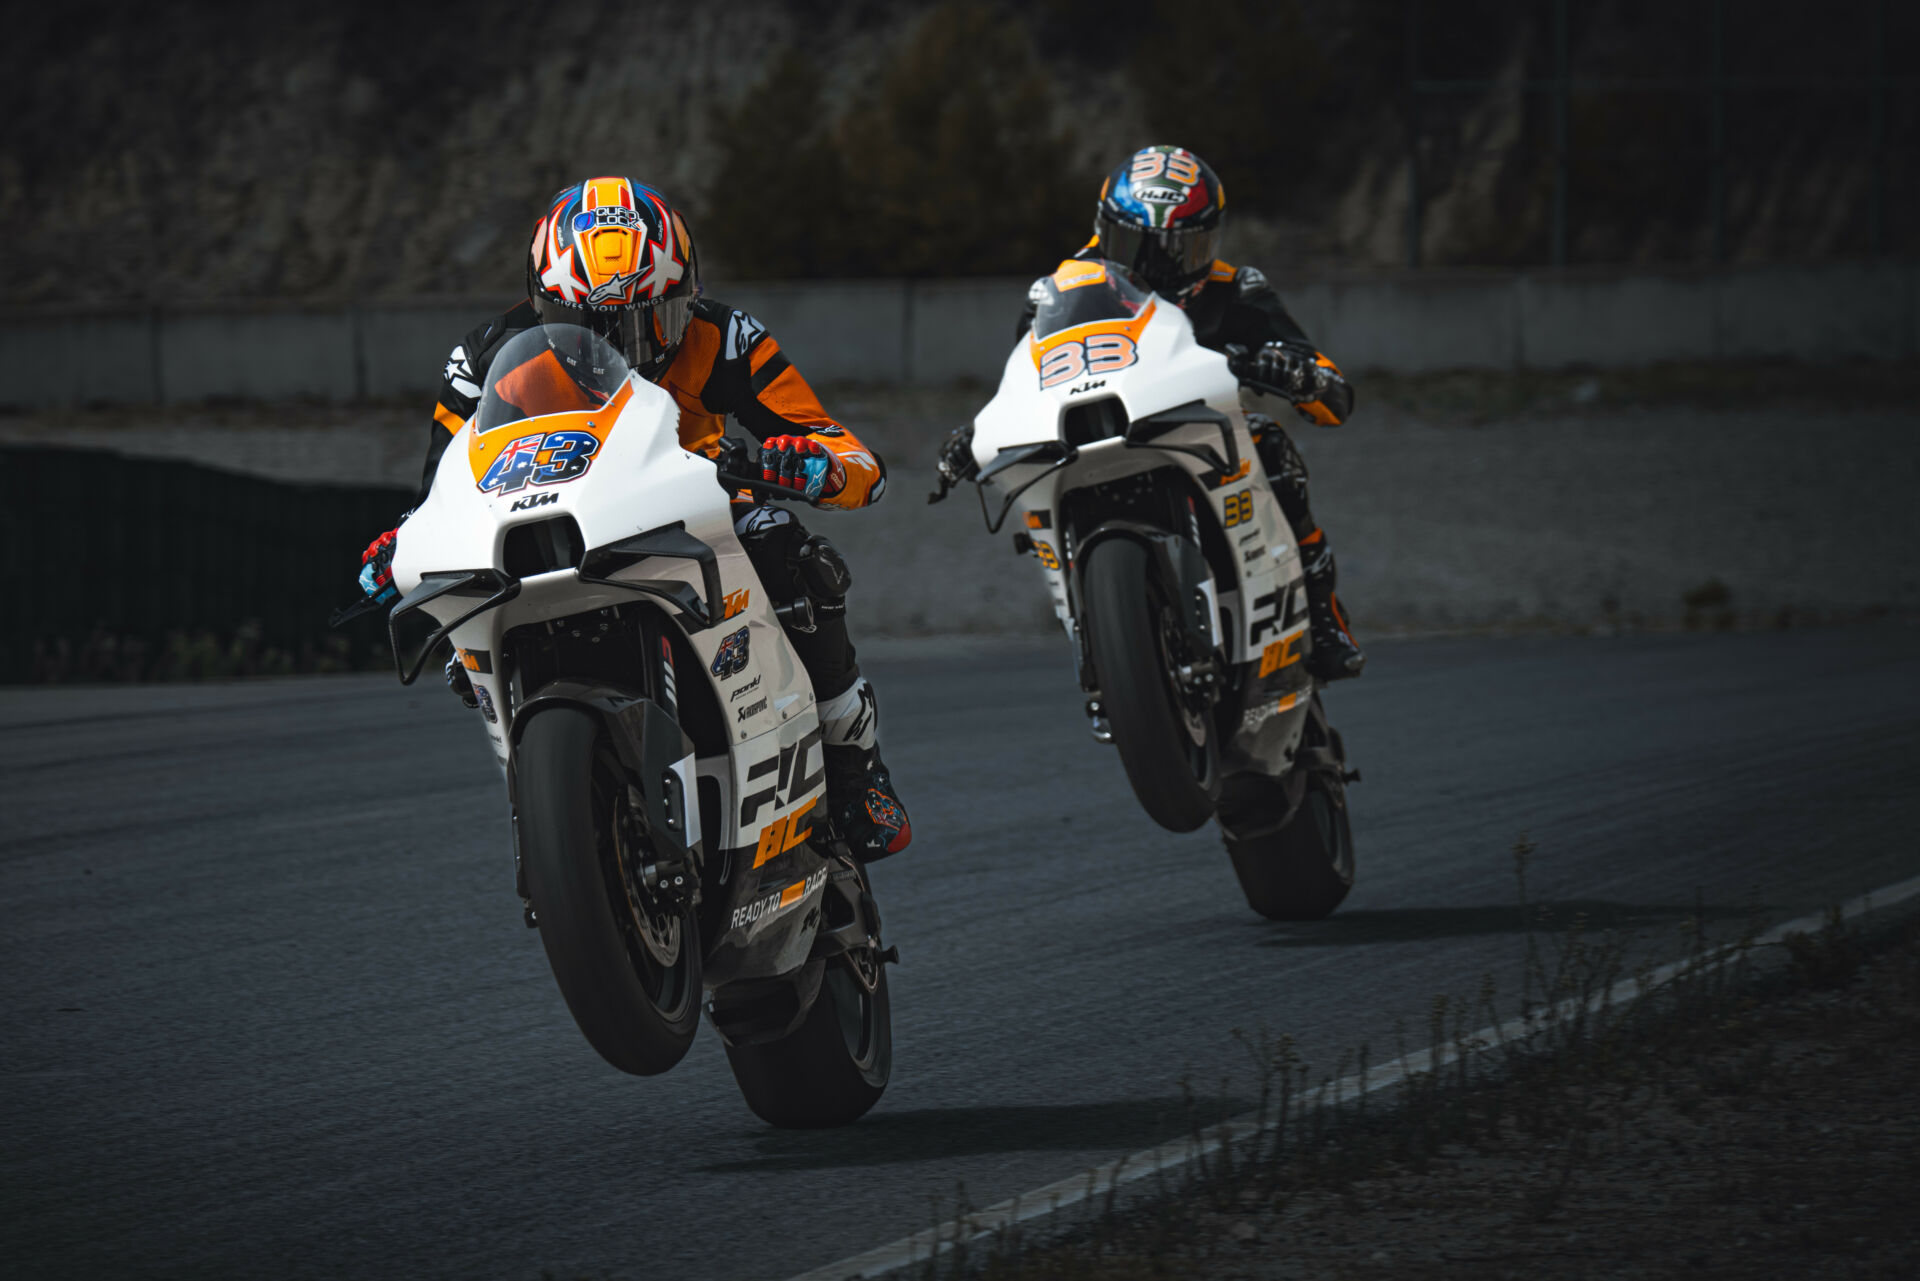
[0,368,1920,636]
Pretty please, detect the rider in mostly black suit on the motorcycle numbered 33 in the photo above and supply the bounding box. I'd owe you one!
[941,146,1367,680]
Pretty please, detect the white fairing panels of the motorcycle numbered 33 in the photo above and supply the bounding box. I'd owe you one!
[973,282,1308,751]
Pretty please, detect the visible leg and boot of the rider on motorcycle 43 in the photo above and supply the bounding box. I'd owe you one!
[733,505,914,862]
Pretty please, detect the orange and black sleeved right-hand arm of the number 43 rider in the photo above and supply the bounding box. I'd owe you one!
[701,311,887,507]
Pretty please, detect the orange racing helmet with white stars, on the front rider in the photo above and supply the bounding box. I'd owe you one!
[526,177,701,380]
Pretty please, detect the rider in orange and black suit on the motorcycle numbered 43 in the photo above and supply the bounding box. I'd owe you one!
[361,177,912,862]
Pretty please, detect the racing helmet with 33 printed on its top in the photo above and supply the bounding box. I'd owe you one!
[1092,146,1227,303]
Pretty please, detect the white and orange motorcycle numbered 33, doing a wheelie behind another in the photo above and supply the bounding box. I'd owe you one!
[929,261,1357,920]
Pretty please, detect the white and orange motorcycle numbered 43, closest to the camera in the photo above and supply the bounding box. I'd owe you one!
[351,325,897,1127]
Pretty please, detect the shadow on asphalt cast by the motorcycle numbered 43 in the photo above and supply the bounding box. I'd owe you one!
[701,1097,1254,1173]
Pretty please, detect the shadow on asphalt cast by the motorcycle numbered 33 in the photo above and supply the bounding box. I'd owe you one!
[1260,899,1761,947]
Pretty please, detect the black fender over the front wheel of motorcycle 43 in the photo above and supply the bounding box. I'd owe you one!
[507,680,705,866]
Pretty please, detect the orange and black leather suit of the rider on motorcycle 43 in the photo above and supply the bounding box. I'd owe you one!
[419,298,887,701]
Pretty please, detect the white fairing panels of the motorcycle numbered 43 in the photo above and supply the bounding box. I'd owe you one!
[394,362,824,964]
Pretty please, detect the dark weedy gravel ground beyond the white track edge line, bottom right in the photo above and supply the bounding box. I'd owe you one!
[1002,924,1920,1281]
